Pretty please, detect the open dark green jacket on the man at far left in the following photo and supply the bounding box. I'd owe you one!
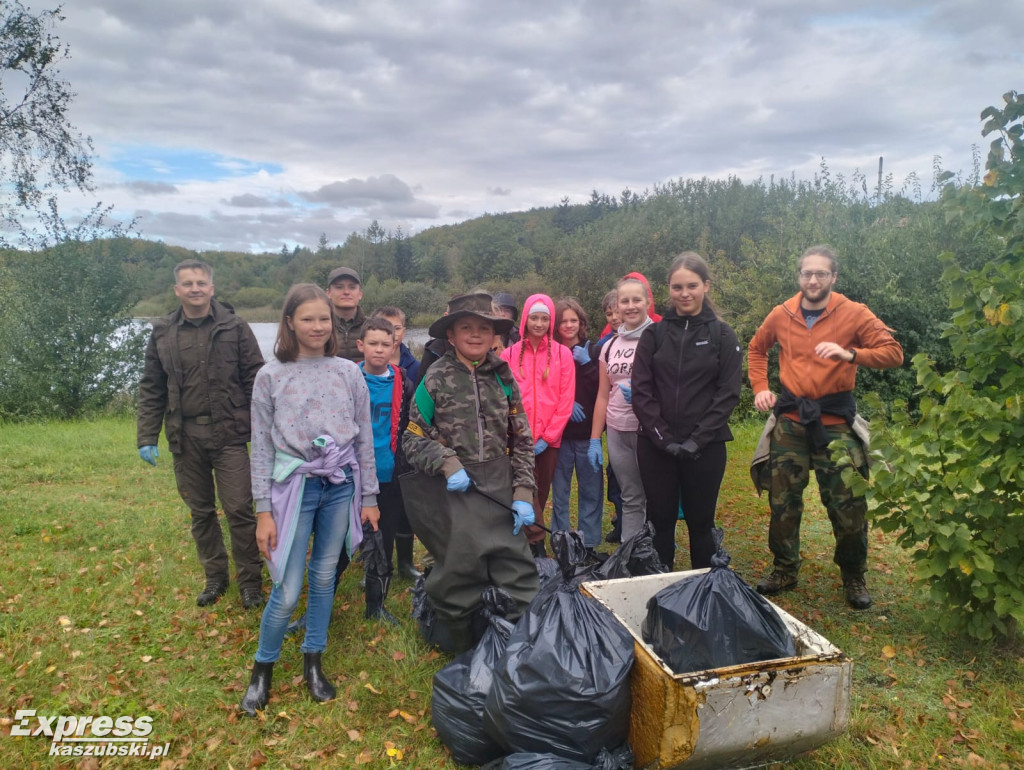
[136,300,263,453]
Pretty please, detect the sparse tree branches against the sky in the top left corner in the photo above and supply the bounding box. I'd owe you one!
[0,0,92,243]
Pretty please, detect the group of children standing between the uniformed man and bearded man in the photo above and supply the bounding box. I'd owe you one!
[242,253,741,714]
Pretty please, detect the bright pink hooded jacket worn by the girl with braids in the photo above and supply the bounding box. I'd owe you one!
[502,294,575,446]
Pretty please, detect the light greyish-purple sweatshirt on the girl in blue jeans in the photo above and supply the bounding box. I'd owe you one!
[250,356,379,512]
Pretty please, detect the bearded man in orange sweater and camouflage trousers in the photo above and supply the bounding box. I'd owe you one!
[748,246,903,609]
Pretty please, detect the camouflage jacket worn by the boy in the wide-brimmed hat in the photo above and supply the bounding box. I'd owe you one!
[402,350,536,503]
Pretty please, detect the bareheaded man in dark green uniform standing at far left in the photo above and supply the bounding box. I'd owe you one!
[137,260,263,609]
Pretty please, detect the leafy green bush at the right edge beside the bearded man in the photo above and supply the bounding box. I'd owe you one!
[844,91,1024,639]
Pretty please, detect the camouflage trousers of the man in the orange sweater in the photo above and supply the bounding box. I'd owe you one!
[768,417,867,575]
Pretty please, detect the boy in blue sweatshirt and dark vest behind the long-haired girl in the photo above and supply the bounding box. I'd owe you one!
[356,316,414,623]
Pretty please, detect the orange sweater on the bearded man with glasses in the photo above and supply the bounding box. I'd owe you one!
[746,292,903,424]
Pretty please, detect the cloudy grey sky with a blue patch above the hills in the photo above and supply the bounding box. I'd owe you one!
[44,0,1024,251]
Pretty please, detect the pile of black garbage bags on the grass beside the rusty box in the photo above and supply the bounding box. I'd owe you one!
[430,531,660,770]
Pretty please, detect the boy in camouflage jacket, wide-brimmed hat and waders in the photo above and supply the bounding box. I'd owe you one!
[402,294,539,651]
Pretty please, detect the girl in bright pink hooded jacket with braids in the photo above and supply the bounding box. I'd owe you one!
[502,294,575,556]
